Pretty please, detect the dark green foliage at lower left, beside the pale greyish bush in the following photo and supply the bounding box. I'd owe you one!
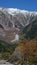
[0,40,17,60]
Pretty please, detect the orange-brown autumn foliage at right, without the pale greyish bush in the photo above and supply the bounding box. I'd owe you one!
[18,40,37,59]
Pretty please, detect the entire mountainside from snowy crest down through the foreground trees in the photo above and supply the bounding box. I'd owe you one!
[0,8,37,65]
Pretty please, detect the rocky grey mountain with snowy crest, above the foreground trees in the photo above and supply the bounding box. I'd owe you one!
[0,8,37,42]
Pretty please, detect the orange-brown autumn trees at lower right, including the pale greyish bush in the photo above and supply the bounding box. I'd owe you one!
[14,39,37,63]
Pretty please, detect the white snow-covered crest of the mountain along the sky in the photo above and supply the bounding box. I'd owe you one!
[0,8,37,15]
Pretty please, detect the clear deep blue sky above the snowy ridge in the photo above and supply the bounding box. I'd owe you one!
[0,0,37,11]
